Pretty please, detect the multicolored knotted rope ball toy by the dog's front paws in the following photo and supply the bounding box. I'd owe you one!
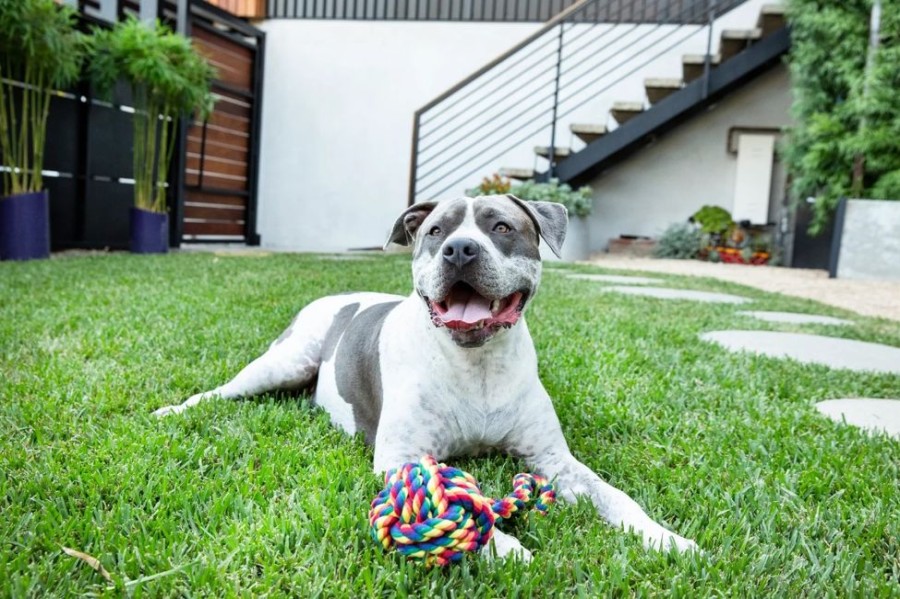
[369,455,556,566]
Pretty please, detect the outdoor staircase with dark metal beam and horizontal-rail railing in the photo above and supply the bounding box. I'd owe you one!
[409,0,789,204]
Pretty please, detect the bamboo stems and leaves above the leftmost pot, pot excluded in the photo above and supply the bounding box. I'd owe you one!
[0,0,86,195]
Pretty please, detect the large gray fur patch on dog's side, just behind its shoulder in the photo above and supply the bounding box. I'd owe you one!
[334,301,400,445]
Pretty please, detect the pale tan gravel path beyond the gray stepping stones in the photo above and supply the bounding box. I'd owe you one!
[582,254,900,321]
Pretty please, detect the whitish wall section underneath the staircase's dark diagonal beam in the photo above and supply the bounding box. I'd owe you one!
[590,66,791,251]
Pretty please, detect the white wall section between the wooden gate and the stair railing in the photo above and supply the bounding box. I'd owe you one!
[257,20,540,251]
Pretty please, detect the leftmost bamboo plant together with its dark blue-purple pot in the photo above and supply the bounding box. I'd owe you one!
[0,0,86,260]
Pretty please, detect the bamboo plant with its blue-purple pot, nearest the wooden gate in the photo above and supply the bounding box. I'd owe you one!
[90,17,215,253]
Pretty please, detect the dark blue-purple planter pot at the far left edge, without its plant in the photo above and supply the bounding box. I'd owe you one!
[0,190,50,260]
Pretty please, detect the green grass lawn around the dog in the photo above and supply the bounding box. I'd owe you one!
[0,253,900,597]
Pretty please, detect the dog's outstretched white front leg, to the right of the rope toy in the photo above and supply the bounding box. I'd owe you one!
[508,388,697,551]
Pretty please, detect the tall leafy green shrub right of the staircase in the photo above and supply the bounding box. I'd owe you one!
[782,0,900,233]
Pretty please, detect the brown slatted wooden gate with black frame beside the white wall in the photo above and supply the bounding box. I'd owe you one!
[176,1,265,245]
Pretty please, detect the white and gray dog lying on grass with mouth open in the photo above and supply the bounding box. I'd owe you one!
[154,195,696,560]
